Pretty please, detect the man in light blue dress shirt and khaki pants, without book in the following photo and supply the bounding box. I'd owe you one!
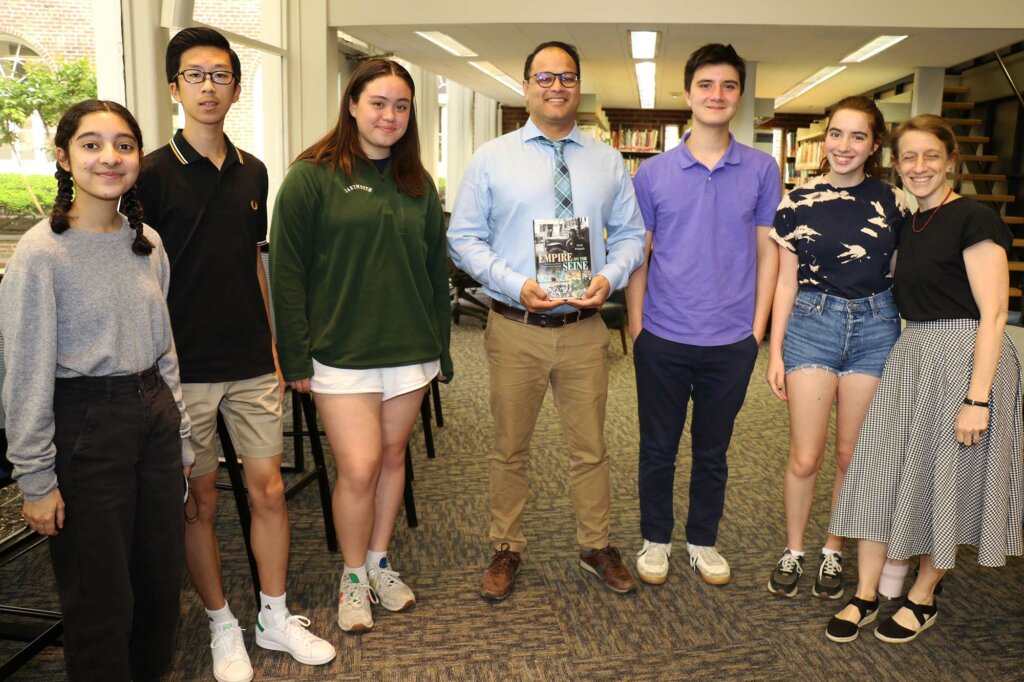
[449,42,644,600]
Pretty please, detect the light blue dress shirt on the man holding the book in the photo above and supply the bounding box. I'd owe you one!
[447,120,644,313]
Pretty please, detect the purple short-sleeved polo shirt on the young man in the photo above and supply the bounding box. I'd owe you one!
[633,133,782,346]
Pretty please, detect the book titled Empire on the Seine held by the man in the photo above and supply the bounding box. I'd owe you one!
[534,217,592,298]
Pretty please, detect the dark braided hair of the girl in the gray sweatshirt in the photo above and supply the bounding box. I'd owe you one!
[50,99,153,256]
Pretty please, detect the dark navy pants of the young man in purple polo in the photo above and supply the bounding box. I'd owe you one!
[633,330,758,546]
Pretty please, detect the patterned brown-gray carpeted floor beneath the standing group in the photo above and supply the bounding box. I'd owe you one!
[0,318,1024,681]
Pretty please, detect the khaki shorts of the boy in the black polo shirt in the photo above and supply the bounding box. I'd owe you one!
[181,374,285,478]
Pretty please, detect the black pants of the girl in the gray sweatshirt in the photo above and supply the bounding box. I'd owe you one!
[49,368,184,681]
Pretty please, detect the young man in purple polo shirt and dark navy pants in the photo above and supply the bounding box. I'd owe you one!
[626,44,781,585]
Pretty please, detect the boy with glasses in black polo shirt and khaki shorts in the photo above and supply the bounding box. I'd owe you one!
[138,28,335,682]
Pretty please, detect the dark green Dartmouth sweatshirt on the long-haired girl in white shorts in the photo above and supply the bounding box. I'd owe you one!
[270,161,453,381]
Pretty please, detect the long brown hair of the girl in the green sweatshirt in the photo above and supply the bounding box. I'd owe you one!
[295,58,427,197]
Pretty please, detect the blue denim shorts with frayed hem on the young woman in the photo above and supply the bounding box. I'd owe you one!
[782,291,900,377]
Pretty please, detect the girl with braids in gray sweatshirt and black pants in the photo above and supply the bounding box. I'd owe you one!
[0,99,194,680]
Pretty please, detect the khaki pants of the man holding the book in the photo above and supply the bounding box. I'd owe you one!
[484,312,609,552]
